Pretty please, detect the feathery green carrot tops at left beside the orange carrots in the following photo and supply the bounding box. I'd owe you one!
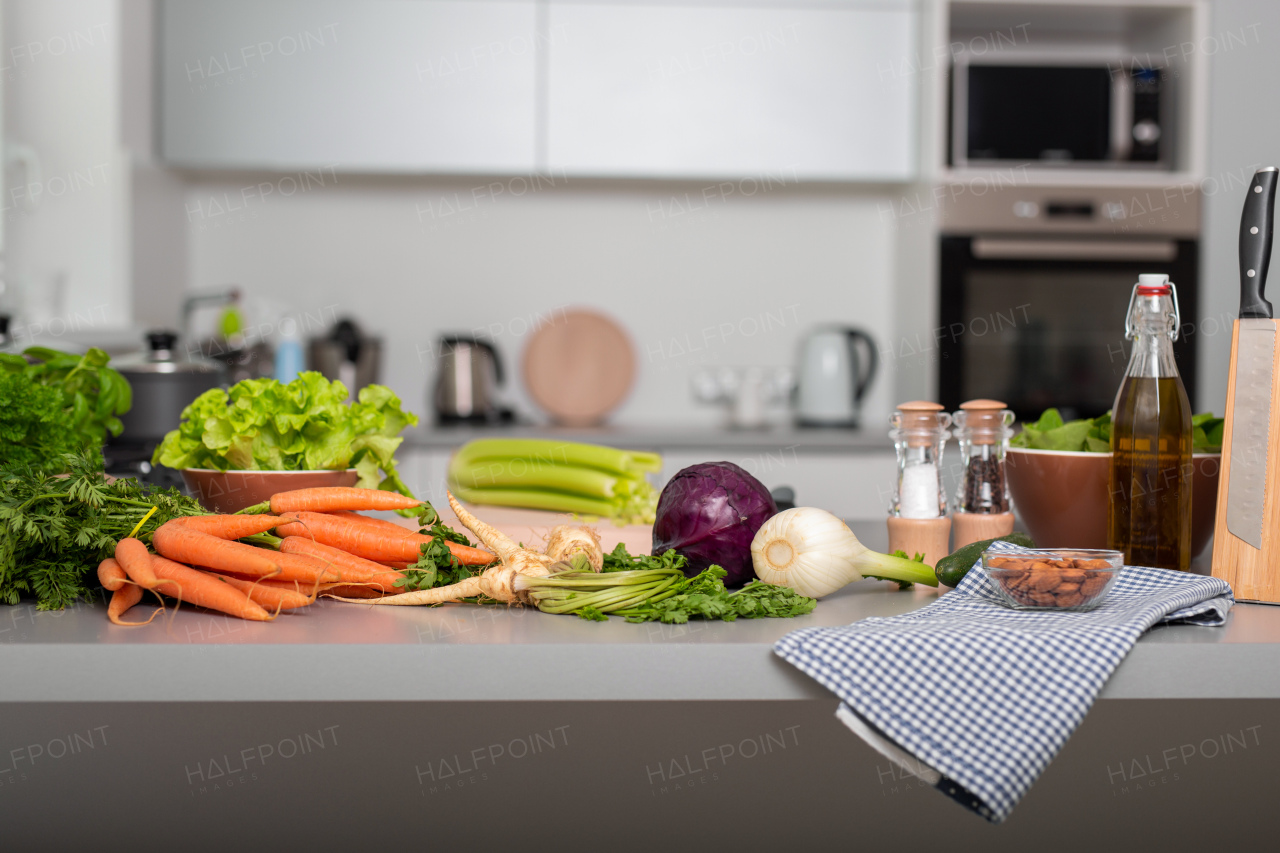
[0,451,205,610]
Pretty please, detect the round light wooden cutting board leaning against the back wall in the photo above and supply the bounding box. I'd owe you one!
[524,309,636,427]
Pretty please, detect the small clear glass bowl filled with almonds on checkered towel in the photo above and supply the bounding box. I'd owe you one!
[982,548,1124,611]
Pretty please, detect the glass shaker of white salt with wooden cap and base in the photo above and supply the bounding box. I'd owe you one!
[888,401,951,565]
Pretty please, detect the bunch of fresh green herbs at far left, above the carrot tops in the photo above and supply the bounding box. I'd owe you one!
[0,347,133,466]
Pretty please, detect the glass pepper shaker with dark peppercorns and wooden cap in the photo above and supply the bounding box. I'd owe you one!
[952,400,1014,548]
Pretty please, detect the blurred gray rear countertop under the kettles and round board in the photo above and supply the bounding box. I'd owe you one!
[404,425,893,453]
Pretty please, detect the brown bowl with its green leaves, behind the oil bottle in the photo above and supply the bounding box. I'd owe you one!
[1005,409,1222,556]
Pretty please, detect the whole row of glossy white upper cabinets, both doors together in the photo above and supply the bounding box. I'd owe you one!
[157,0,919,183]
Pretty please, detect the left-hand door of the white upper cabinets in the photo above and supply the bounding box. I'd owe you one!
[159,0,538,172]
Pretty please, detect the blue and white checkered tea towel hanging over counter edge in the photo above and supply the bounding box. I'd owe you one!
[773,543,1235,824]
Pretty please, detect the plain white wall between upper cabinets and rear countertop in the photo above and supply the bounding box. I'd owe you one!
[184,172,896,425]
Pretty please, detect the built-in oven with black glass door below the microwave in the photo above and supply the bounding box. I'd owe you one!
[938,188,1199,420]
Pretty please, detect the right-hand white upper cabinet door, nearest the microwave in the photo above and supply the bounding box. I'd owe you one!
[547,0,918,180]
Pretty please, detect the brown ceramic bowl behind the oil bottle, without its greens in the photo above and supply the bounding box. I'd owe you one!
[1005,447,1222,557]
